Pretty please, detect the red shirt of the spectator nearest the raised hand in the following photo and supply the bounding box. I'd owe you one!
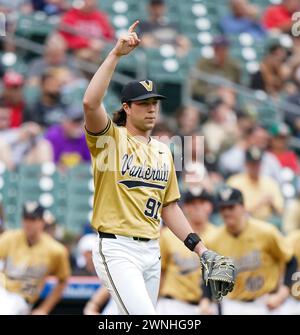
[60,1,114,49]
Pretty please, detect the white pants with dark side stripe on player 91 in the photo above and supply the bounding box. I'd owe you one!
[93,235,161,315]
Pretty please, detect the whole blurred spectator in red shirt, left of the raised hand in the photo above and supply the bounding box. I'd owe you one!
[60,0,114,60]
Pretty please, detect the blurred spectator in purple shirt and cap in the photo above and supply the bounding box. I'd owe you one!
[45,106,90,169]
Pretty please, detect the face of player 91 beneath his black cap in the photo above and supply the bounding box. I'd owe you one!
[127,99,159,131]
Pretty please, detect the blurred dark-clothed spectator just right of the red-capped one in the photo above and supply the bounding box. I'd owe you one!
[31,70,66,128]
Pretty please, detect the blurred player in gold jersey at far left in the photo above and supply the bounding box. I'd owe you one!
[0,202,70,315]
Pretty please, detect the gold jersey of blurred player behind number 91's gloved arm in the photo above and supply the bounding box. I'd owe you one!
[160,223,218,303]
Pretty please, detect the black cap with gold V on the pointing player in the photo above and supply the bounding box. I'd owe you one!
[121,79,166,103]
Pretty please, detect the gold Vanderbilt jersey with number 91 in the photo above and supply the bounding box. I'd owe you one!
[86,119,180,239]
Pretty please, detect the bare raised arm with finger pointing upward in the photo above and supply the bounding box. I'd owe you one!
[83,20,140,133]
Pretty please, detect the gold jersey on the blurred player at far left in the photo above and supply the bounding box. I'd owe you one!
[0,230,70,304]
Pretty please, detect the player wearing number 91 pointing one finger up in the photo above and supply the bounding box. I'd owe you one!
[83,21,234,314]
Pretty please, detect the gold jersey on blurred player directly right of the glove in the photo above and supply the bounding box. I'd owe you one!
[207,218,293,300]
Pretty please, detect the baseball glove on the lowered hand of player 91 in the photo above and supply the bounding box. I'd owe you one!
[200,250,236,301]
